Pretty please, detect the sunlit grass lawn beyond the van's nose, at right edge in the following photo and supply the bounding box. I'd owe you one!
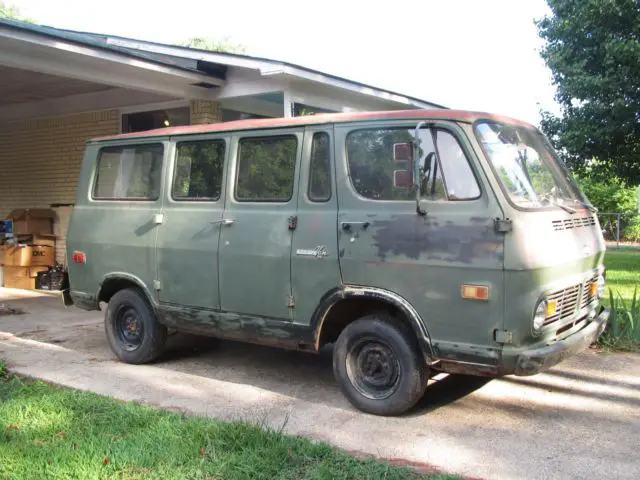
[604,248,640,304]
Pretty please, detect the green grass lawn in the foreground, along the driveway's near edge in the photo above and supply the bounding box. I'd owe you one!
[0,363,455,480]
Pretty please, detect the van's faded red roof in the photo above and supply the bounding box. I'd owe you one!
[91,109,531,141]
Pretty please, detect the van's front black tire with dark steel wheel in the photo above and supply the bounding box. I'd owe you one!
[333,313,429,416]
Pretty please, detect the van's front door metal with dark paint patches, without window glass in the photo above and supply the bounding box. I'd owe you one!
[336,122,504,363]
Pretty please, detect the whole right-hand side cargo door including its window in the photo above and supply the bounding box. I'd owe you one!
[219,129,303,321]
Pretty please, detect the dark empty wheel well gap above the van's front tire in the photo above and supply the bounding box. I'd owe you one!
[318,298,417,348]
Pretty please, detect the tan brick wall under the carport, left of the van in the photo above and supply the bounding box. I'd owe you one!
[0,110,118,261]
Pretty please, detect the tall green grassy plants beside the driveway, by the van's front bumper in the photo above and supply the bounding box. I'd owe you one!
[600,286,640,351]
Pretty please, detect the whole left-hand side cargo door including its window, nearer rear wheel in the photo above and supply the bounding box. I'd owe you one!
[157,136,228,309]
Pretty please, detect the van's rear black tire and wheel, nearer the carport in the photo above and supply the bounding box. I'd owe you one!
[104,288,167,364]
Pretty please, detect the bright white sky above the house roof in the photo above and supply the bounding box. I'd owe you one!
[4,0,558,124]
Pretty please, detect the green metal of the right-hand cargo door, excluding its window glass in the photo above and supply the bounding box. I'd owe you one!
[218,129,304,321]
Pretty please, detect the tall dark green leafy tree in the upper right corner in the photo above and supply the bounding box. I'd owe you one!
[536,0,640,184]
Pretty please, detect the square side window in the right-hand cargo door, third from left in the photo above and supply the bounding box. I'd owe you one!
[235,136,298,202]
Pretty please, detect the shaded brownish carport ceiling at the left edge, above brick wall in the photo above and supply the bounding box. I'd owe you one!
[0,65,112,106]
